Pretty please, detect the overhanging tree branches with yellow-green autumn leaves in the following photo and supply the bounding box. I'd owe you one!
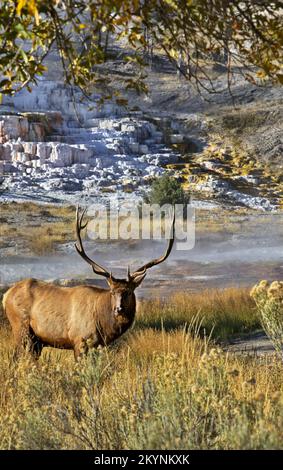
[0,0,283,100]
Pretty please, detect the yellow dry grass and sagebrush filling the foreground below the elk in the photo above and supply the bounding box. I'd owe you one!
[0,289,283,449]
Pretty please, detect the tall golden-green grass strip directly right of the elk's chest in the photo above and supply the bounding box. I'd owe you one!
[137,288,259,340]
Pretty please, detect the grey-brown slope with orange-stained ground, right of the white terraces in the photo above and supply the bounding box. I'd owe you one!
[122,62,283,207]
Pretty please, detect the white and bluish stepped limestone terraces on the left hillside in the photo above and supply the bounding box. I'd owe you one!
[0,81,180,204]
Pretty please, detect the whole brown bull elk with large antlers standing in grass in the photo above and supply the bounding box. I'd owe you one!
[3,209,175,360]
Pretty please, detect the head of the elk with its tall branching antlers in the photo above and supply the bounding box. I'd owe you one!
[75,208,175,318]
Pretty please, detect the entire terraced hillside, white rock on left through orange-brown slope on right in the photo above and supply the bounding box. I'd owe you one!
[0,56,283,210]
